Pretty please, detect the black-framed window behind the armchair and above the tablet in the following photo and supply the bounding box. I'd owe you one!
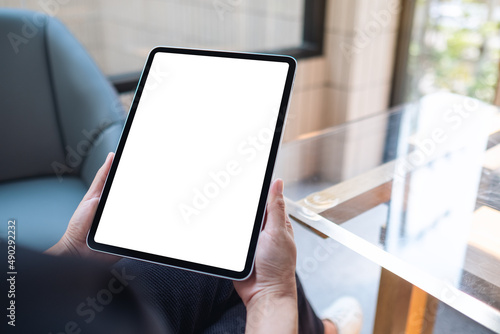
[0,0,325,92]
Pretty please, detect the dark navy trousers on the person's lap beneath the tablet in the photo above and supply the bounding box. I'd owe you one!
[118,259,324,334]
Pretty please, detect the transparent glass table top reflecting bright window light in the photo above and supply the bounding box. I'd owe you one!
[275,93,500,332]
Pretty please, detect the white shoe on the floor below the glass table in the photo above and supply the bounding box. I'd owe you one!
[321,296,363,334]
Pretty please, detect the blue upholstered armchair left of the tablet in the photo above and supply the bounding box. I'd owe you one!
[0,9,125,251]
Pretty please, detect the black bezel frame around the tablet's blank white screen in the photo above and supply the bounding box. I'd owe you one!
[87,47,297,280]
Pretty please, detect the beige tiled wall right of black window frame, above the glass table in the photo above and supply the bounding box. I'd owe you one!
[285,0,401,141]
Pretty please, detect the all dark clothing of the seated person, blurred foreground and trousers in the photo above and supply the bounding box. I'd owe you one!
[8,244,324,334]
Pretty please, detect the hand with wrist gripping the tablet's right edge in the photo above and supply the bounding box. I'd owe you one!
[234,179,298,333]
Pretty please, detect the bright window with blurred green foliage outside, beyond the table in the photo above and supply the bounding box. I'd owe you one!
[393,0,500,104]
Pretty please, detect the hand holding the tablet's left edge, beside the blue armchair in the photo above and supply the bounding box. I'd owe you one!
[45,153,119,263]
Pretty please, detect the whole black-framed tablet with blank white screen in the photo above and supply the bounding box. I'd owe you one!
[87,47,296,279]
